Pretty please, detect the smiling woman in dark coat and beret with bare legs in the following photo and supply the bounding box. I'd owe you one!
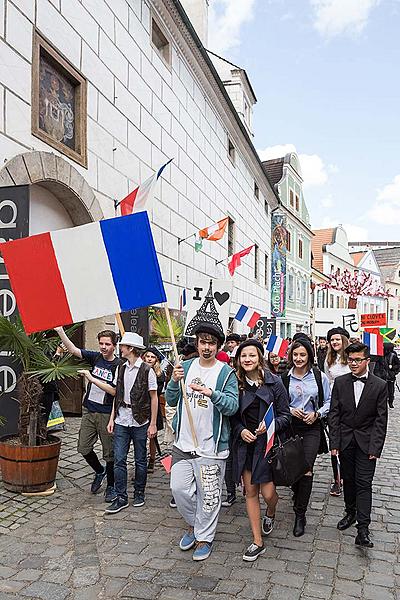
[231,339,291,561]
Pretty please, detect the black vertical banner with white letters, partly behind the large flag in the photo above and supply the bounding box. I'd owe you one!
[0,185,29,435]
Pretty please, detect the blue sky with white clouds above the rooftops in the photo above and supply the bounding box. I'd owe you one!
[208,0,400,241]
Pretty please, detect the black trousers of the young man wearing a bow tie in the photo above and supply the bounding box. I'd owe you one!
[339,438,376,529]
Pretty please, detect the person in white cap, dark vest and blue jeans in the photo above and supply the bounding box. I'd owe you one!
[106,332,158,514]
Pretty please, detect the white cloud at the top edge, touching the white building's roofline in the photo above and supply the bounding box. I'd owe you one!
[208,0,255,55]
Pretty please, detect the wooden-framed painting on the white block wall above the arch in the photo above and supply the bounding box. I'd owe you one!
[32,32,87,167]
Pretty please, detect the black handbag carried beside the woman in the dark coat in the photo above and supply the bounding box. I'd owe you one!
[269,435,310,487]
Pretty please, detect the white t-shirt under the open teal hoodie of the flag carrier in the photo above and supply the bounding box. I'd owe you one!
[175,358,229,459]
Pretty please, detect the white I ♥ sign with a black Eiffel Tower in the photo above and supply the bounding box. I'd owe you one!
[185,277,233,336]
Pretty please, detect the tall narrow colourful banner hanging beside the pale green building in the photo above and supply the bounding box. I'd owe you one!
[271,213,287,317]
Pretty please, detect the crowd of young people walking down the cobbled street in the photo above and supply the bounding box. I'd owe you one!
[57,322,392,561]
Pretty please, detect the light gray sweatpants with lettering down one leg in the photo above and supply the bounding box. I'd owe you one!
[171,456,226,542]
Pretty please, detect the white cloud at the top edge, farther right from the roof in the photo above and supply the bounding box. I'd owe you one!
[310,0,381,38]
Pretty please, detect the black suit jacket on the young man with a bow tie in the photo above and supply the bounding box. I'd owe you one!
[328,373,388,457]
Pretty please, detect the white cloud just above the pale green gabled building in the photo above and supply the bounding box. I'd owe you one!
[258,144,330,187]
